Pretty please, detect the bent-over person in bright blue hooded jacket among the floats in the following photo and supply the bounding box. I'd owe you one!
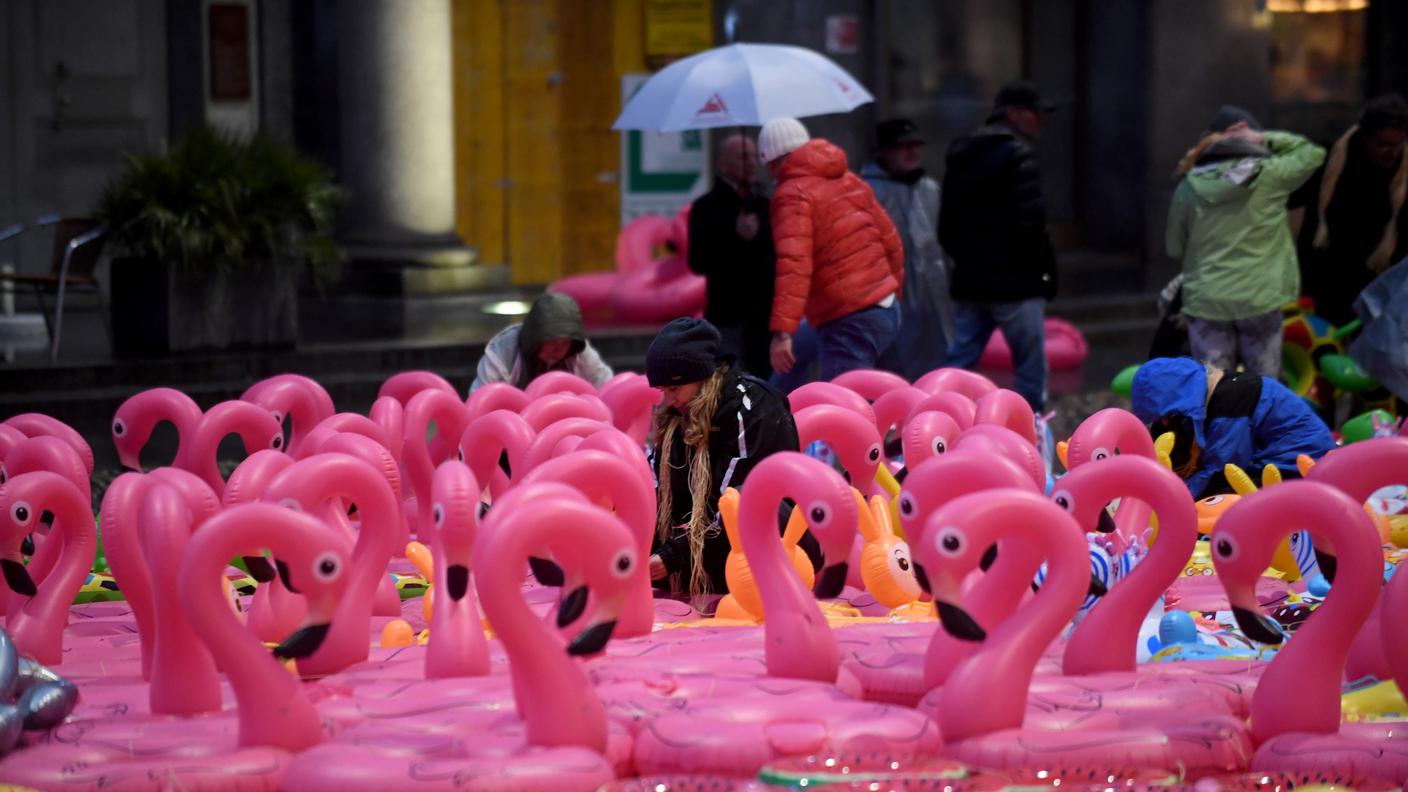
[1132,358,1335,497]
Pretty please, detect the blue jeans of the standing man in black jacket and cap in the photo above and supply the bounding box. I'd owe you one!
[948,297,1046,413]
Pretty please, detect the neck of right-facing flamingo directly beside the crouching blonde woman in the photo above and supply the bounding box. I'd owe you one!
[738,469,841,682]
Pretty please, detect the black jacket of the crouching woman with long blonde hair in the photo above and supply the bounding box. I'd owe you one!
[650,368,798,593]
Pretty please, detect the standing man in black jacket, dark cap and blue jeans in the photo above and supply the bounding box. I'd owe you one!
[939,82,1056,412]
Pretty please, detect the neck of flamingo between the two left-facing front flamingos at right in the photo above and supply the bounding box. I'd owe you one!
[1062,476,1198,674]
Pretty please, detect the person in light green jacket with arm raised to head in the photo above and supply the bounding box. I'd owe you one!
[1164,106,1325,378]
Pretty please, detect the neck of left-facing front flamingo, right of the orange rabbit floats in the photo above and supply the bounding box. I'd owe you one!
[939,526,1090,741]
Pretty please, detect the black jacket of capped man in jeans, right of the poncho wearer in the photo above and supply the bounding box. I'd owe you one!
[939,123,1056,303]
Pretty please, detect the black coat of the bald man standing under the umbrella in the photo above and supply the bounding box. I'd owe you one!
[690,179,777,325]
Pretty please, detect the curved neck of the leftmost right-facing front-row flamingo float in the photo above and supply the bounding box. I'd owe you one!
[180,524,322,753]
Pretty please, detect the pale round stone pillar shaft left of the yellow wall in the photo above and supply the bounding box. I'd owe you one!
[337,0,473,274]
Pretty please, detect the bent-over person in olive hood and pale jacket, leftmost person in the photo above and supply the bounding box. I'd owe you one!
[469,292,611,393]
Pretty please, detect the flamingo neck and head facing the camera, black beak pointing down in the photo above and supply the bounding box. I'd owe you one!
[425,459,489,679]
